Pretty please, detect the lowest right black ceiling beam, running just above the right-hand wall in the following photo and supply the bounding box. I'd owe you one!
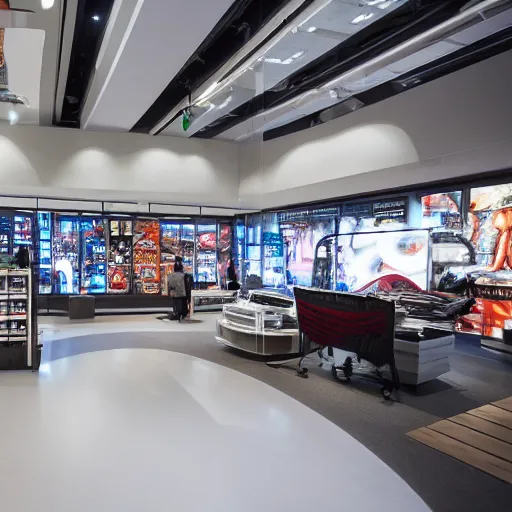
[263,27,512,141]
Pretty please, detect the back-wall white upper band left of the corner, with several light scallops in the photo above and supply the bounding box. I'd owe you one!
[0,125,239,208]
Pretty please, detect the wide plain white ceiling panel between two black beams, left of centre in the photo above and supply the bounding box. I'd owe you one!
[82,0,238,131]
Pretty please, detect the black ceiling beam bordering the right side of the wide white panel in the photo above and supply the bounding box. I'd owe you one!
[131,0,313,133]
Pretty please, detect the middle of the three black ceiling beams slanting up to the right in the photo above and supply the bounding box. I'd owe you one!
[194,0,467,139]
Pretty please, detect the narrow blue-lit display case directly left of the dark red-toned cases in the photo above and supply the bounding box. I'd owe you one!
[80,217,107,295]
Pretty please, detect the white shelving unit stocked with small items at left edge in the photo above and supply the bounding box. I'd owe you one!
[0,269,33,370]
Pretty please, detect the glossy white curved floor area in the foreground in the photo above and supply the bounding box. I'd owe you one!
[0,349,428,512]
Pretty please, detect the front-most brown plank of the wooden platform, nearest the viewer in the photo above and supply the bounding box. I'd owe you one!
[407,428,512,484]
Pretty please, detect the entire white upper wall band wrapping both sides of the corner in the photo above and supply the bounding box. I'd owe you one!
[0,51,512,210]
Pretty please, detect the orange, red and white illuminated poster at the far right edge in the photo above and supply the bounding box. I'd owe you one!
[439,184,512,340]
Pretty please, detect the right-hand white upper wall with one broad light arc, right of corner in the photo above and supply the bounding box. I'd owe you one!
[240,51,512,208]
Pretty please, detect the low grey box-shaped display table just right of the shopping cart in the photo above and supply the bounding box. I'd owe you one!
[394,334,455,386]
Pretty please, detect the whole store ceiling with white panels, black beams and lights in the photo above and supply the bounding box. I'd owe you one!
[0,0,512,142]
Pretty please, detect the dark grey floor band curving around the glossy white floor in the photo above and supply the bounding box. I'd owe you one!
[43,319,512,512]
